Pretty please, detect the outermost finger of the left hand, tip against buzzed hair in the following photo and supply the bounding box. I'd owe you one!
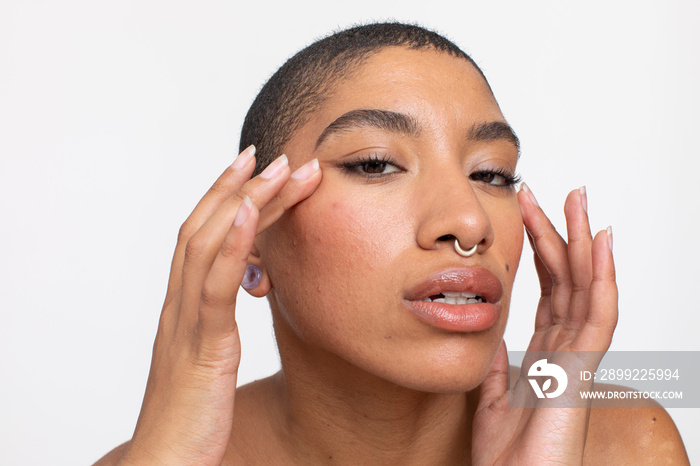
[166,146,255,297]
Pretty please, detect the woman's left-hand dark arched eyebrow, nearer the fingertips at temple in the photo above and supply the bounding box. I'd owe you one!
[316,109,420,148]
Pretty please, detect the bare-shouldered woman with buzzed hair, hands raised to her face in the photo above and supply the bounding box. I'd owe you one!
[101,24,687,464]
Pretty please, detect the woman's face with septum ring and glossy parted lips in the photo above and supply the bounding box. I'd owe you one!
[258,47,523,392]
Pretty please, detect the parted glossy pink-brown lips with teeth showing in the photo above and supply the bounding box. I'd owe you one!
[404,267,503,333]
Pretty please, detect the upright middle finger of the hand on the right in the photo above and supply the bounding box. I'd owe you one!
[564,187,593,329]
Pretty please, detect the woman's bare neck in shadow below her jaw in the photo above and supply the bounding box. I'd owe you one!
[274,314,475,465]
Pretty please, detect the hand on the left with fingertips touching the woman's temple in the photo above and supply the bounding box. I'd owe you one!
[115,146,321,465]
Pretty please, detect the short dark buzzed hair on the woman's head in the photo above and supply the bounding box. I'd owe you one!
[240,23,488,176]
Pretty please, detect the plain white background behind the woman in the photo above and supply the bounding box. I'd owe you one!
[0,0,700,465]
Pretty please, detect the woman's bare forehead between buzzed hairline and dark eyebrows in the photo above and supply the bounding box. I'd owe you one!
[289,47,505,157]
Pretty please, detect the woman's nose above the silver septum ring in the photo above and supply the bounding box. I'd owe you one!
[416,167,494,254]
